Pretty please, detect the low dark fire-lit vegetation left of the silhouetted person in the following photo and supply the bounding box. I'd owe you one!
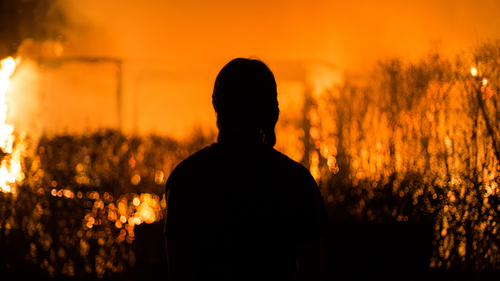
[0,130,215,280]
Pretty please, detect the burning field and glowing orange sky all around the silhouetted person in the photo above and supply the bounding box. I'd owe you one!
[0,0,500,280]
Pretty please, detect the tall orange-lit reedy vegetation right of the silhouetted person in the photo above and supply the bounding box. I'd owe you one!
[306,41,500,278]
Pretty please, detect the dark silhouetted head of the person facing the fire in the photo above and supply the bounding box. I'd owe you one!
[212,58,279,147]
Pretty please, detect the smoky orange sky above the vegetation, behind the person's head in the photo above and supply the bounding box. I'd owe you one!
[8,0,500,136]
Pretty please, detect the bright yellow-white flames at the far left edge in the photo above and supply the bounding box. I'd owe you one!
[0,57,26,195]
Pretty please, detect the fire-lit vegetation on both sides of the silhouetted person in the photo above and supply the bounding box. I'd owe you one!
[0,42,500,280]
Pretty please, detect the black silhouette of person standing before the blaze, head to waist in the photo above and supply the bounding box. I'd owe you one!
[165,58,329,281]
